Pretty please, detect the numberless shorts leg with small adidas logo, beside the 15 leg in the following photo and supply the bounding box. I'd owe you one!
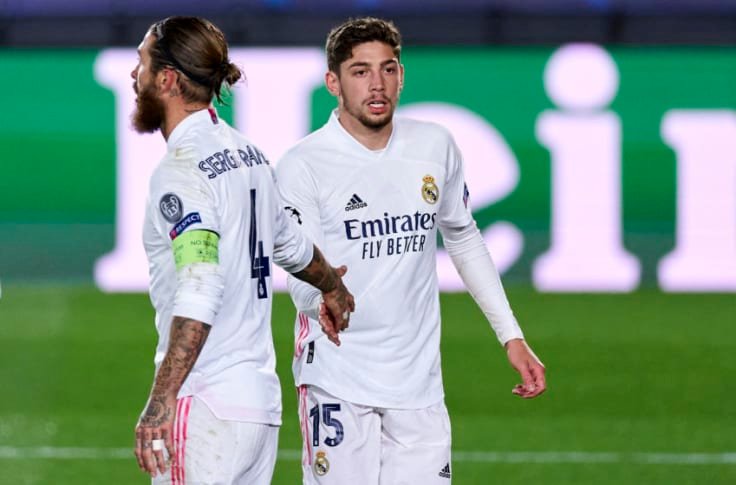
[380,402,451,485]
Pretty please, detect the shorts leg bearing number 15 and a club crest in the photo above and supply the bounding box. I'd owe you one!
[298,386,381,485]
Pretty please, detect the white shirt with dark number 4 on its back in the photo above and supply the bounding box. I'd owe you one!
[143,109,313,425]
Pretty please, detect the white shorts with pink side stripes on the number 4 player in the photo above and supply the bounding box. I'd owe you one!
[152,396,279,485]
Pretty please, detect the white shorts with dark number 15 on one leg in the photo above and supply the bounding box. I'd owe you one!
[297,386,451,485]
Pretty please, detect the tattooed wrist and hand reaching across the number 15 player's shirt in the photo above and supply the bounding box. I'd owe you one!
[292,246,355,345]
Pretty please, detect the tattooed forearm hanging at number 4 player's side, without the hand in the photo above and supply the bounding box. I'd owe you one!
[144,317,210,426]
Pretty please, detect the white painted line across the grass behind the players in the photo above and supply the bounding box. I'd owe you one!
[0,446,736,465]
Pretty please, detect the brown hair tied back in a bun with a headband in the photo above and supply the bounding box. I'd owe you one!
[149,16,243,103]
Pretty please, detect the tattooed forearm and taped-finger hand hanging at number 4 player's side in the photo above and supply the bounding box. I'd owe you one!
[135,317,210,477]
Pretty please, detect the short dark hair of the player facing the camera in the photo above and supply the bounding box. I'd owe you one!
[325,17,401,74]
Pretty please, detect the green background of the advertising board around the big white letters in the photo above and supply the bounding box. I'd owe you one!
[0,47,736,286]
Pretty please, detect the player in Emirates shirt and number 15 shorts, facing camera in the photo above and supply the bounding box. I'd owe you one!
[277,18,546,485]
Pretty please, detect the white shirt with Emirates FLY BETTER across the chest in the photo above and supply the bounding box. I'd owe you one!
[277,113,516,409]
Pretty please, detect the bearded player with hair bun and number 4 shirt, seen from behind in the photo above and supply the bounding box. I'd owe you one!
[131,17,354,484]
